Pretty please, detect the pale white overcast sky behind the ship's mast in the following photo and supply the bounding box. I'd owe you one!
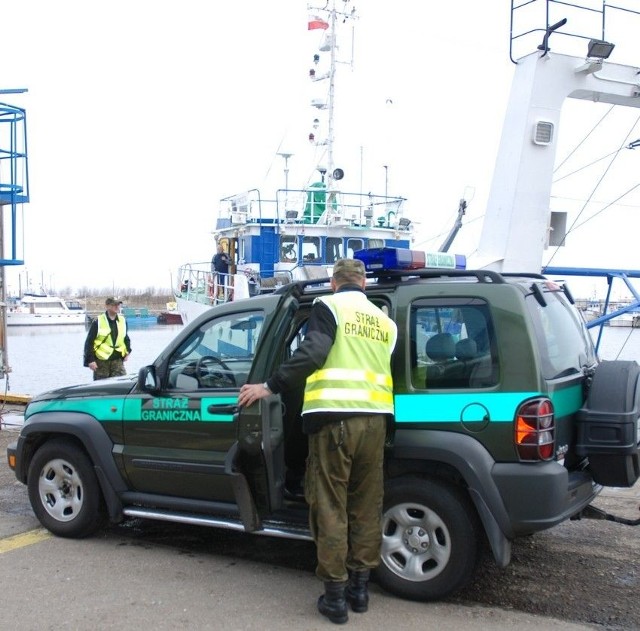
[0,0,640,300]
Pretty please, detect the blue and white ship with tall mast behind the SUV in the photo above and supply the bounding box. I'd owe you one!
[174,1,422,324]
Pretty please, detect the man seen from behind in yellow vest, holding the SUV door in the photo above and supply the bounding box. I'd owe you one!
[238,259,397,624]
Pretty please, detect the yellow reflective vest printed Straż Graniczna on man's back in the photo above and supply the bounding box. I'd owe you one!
[302,291,397,414]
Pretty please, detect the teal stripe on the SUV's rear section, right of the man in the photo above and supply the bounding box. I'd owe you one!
[395,385,582,423]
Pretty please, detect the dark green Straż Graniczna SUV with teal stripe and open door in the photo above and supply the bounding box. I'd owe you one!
[8,249,640,600]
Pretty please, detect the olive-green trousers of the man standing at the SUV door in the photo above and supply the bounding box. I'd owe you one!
[304,414,386,581]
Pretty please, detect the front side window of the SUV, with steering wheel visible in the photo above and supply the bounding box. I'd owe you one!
[167,311,264,390]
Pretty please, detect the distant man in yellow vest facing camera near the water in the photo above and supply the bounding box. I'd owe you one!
[84,298,131,381]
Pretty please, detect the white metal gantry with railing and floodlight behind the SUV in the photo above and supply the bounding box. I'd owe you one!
[468,0,640,348]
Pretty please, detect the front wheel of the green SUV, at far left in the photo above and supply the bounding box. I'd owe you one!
[27,440,106,538]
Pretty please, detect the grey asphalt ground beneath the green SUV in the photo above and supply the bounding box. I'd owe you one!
[0,427,640,631]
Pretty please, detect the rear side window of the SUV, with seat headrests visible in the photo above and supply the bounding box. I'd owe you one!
[409,298,498,389]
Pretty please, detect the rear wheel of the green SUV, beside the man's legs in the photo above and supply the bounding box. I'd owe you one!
[376,478,479,601]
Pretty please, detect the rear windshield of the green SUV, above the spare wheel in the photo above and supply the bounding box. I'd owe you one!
[526,291,596,379]
